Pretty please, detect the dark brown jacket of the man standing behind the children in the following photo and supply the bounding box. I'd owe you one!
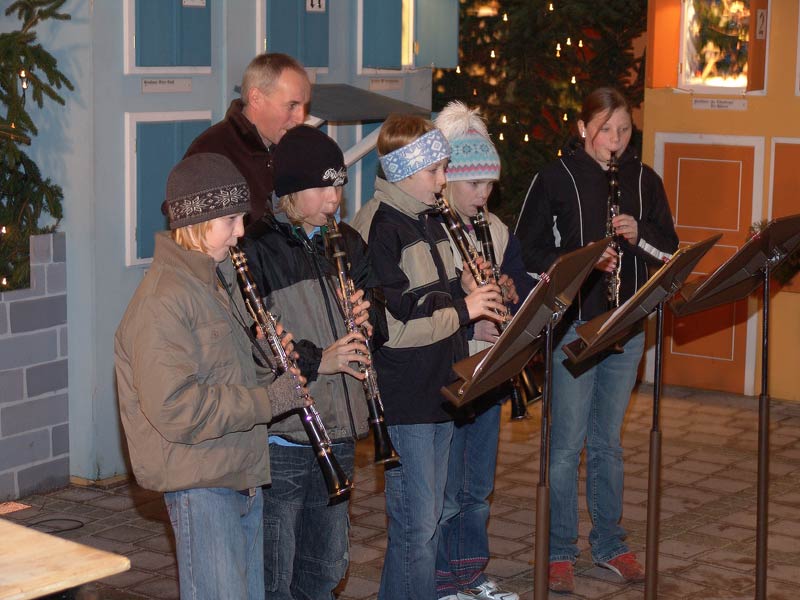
[184,99,273,223]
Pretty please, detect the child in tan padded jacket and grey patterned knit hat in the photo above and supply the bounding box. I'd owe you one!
[114,153,306,600]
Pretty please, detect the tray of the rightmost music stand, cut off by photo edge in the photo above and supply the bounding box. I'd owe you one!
[670,214,800,317]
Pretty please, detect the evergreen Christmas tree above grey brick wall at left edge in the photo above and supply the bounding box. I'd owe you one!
[0,0,72,291]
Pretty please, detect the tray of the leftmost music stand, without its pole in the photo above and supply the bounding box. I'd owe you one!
[441,238,609,407]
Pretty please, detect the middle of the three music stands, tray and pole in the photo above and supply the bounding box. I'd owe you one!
[564,234,722,598]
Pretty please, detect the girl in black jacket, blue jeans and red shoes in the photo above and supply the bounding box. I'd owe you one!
[516,88,678,592]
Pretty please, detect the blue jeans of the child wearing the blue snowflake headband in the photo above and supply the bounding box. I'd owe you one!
[378,422,453,600]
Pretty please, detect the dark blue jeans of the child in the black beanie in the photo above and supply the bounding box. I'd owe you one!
[264,442,355,600]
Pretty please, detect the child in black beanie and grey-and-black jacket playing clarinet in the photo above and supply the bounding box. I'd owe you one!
[242,126,376,600]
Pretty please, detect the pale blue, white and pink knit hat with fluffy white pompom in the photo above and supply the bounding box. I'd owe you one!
[434,101,500,181]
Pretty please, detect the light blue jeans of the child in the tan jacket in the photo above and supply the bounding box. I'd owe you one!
[164,488,264,600]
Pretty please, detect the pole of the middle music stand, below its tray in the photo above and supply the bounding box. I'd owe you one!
[644,301,664,600]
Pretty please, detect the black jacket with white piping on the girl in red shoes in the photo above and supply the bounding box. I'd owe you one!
[515,145,678,321]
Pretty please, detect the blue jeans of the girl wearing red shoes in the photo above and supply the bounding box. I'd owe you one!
[550,323,644,562]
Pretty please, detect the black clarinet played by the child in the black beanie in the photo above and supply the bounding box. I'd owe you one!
[325,217,400,471]
